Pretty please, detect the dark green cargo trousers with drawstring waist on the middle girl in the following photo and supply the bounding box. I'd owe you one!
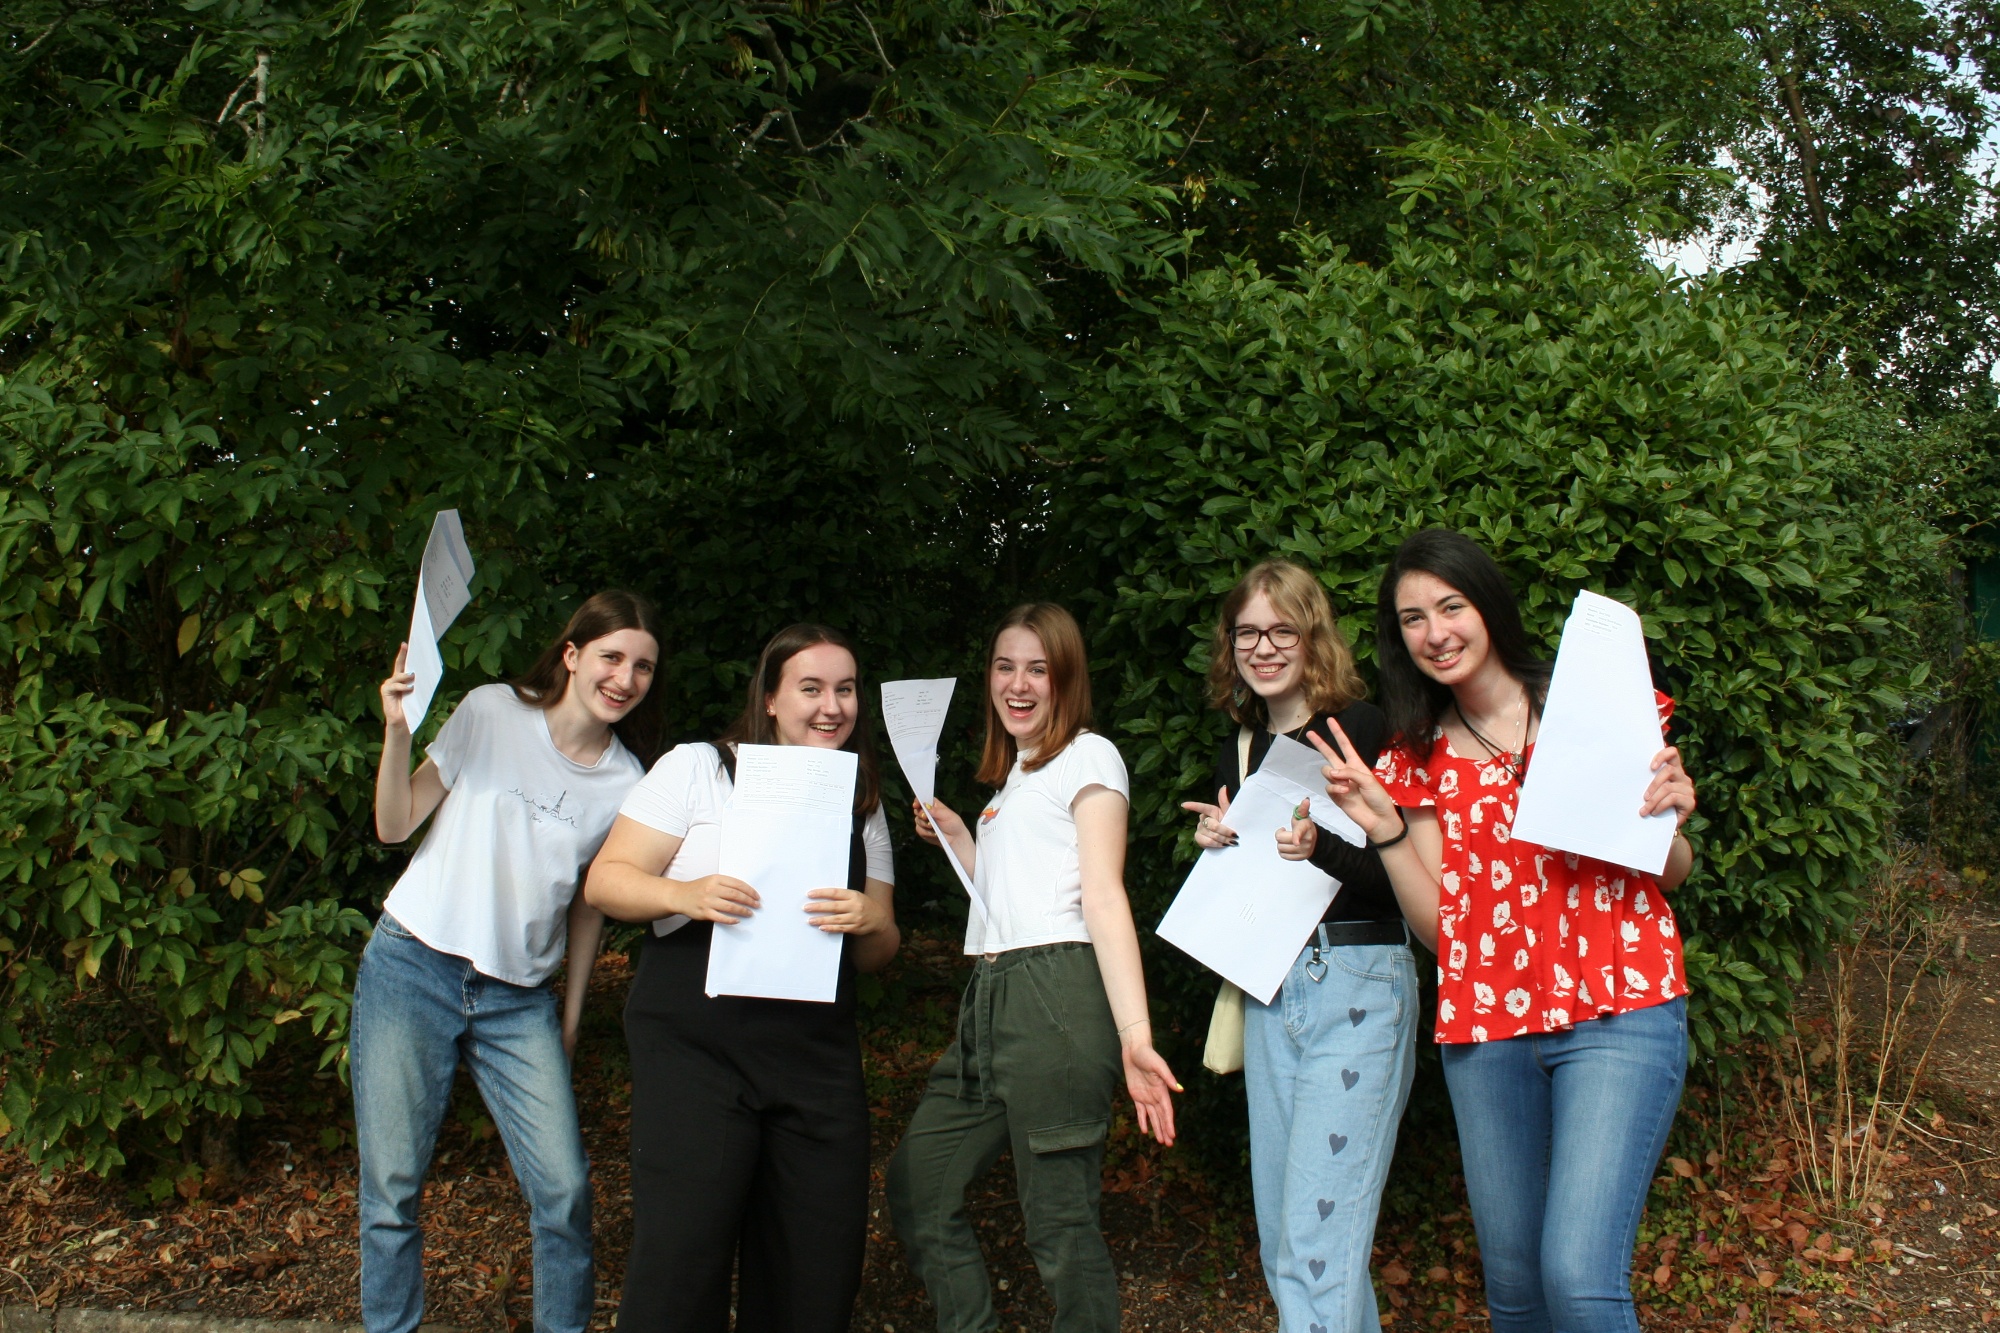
[888,943,1124,1333]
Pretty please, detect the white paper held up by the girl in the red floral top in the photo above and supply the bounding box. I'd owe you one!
[1514,592,1674,875]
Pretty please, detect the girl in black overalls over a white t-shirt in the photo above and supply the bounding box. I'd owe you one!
[584,624,898,1333]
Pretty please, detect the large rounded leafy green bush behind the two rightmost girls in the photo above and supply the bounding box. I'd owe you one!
[1058,124,1932,1080]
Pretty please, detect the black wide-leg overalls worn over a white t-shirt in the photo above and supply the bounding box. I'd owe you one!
[618,792,868,1333]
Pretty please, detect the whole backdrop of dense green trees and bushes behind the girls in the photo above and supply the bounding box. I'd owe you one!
[0,0,1994,1171]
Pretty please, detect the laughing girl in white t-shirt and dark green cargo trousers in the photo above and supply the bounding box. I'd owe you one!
[888,602,1180,1333]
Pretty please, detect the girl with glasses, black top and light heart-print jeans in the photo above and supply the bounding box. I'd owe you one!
[1182,560,1418,1333]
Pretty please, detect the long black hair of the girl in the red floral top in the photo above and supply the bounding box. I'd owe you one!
[1376,528,1550,753]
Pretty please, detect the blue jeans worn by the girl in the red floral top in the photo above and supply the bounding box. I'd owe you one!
[1444,999,1688,1333]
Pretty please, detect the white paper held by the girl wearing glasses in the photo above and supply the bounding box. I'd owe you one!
[1160,737,1360,1005]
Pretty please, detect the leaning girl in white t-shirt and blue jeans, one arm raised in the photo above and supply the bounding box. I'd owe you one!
[348,592,660,1333]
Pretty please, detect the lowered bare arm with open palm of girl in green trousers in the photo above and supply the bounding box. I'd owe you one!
[1070,787,1180,1143]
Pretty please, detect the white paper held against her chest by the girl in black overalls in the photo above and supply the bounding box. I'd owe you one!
[704,745,858,1003]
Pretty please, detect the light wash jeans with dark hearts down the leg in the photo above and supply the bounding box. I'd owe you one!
[1244,924,1416,1333]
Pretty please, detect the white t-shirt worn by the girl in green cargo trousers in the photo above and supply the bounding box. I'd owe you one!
[966,731,1132,953]
